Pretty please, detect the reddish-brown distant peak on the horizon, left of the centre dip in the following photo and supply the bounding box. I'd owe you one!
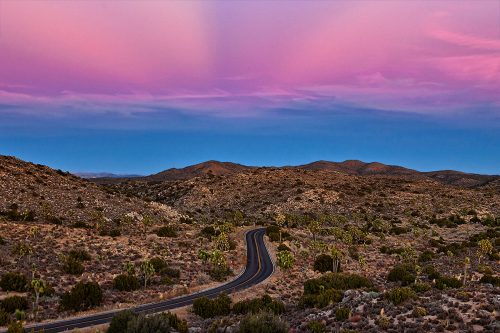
[143,161,255,181]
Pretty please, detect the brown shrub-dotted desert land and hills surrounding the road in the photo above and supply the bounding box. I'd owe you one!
[0,156,500,332]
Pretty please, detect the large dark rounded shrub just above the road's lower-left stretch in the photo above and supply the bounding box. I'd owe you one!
[61,282,103,311]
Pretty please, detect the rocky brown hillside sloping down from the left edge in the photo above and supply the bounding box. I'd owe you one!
[0,156,178,230]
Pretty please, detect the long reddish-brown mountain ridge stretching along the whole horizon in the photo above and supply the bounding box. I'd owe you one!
[92,160,500,188]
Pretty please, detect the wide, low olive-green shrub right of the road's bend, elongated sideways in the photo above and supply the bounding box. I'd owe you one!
[304,273,373,294]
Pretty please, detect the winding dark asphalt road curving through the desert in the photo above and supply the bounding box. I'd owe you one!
[9,228,274,333]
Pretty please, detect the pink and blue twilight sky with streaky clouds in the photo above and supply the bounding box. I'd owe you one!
[0,0,500,174]
